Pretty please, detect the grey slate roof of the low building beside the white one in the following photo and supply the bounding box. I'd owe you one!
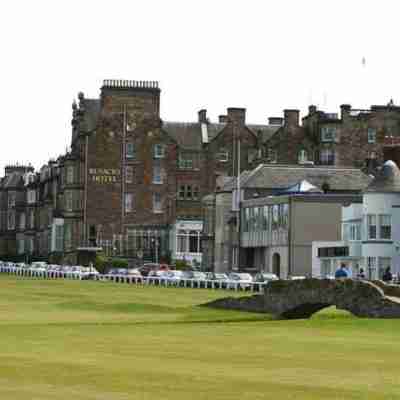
[222,164,372,192]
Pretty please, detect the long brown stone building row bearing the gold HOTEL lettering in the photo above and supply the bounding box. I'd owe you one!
[0,80,278,264]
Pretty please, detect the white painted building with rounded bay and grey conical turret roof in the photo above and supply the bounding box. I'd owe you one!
[313,161,400,279]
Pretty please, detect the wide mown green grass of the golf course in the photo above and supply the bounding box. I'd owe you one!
[0,276,400,400]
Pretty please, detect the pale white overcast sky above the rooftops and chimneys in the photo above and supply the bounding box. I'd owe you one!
[0,0,400,175]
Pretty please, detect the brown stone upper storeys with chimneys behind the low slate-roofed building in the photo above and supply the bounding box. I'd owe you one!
[257,102,400,172]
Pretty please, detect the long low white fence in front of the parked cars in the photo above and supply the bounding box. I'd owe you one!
[0,265,267,292]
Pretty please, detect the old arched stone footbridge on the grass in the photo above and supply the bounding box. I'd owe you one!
[205,279,400,319]
